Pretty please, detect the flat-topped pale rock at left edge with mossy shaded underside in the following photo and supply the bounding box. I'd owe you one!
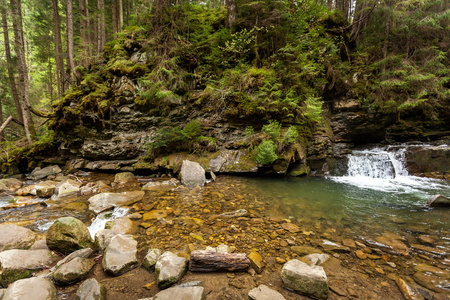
[0,249,55,287]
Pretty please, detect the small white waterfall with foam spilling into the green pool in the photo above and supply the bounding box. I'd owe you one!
[331,146,448,199]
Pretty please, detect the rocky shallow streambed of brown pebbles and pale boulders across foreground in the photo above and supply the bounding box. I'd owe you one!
[0,164,450,299]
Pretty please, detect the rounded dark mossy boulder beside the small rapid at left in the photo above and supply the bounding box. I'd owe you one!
[47,217,92,254]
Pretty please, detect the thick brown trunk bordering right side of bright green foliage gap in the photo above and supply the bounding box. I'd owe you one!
[52,0,66,97]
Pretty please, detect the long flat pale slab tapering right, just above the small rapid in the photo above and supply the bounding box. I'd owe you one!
[88,191,145,214]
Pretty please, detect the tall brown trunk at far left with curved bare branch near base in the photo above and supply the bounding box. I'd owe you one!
[10,0,36,144]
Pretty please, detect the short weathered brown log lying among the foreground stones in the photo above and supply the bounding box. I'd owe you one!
[189,250,250,272]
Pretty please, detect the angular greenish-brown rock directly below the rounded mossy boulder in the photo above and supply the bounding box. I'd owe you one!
[52,257,95,285]
